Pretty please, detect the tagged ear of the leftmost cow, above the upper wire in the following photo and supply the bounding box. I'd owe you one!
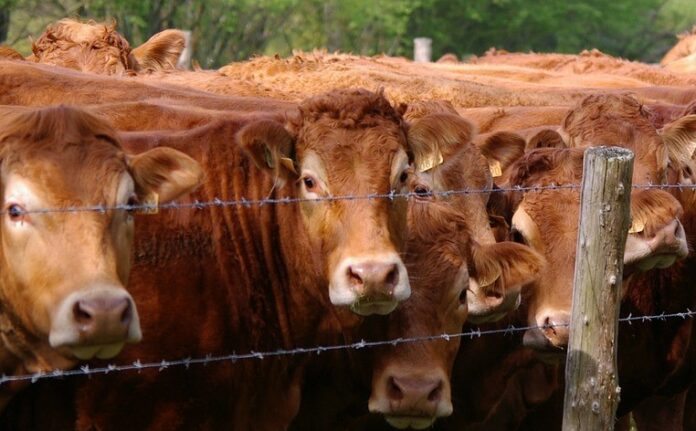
[128,147,204,205]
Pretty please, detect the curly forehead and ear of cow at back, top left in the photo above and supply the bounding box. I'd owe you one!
[31,19,186,75]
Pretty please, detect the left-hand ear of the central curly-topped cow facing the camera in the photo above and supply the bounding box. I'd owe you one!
[237,120,298,186]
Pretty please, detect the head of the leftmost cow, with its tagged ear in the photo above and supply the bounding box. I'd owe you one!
[0,107,202,369]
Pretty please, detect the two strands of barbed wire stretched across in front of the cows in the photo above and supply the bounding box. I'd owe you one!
[0,184,696,386]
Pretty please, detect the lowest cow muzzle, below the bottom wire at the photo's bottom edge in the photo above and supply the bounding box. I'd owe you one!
[368,369,453,429]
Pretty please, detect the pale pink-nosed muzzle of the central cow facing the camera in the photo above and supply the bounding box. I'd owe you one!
[329,253,411,316]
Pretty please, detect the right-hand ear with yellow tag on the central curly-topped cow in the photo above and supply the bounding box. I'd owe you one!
[408,113,474,172]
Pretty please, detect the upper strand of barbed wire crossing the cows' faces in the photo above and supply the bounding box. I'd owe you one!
[6,184,696,215]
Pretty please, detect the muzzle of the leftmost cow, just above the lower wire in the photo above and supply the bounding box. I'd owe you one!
[49,286,142,360]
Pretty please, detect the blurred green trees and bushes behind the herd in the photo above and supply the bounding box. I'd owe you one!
[0,0,696,68]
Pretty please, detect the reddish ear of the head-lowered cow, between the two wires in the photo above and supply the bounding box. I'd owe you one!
[469,241,546,290]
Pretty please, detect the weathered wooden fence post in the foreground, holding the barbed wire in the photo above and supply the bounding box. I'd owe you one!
[563,147,633,431]
